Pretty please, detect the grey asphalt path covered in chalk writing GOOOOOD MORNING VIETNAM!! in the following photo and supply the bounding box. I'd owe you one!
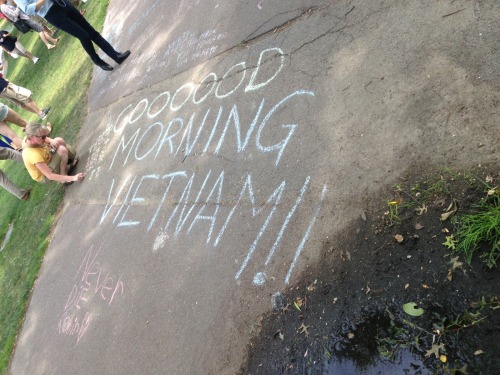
[10,0,500,375]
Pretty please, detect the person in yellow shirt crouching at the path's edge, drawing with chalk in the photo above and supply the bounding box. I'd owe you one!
[22,122,85,185]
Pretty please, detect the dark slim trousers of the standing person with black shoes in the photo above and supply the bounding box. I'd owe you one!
[45,0,118,64]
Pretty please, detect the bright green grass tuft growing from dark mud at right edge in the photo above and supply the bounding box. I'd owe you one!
[453,190,500,268]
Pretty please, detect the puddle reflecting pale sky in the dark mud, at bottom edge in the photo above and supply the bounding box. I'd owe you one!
[323,349,432,375]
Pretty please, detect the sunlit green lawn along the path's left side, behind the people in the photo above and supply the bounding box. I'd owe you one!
[0,1,108,374]
